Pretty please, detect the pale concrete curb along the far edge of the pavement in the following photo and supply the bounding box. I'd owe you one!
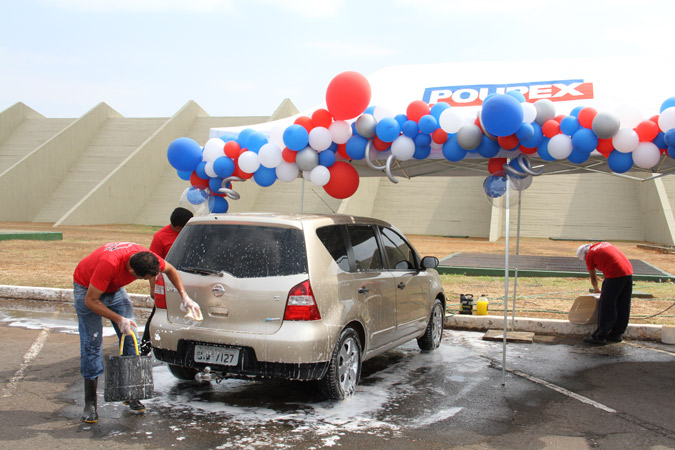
[0,285,662,341]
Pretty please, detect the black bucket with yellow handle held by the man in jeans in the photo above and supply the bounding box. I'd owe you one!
[103,334,155,402]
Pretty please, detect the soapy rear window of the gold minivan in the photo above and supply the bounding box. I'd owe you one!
[167,224,307,278]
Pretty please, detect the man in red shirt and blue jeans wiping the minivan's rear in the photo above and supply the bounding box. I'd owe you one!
[73,242,201,423]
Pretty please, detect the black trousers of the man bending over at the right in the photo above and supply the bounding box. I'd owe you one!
[593,275,633,339]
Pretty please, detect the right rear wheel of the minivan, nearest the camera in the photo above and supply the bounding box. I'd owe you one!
[319,328,361,400]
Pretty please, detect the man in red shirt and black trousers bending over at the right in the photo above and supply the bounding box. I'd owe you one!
[577,242,633,345]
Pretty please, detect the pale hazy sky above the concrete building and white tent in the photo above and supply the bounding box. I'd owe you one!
[0,0,675,117]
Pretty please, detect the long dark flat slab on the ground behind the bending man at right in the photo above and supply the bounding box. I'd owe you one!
[440,253,672,277]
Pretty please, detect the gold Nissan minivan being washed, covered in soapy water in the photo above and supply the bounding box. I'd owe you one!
[150,213,446,400]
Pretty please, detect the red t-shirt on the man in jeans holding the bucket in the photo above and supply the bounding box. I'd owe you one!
[73,242,165,293]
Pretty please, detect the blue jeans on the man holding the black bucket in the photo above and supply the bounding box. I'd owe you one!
[73,283,136,380]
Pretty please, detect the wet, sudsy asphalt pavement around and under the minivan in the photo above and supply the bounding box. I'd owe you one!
[0,303,675,449]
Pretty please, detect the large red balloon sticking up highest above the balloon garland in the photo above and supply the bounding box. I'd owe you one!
[326,71,371,120]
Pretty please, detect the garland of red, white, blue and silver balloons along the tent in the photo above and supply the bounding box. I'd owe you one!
[167,72,675,213]
